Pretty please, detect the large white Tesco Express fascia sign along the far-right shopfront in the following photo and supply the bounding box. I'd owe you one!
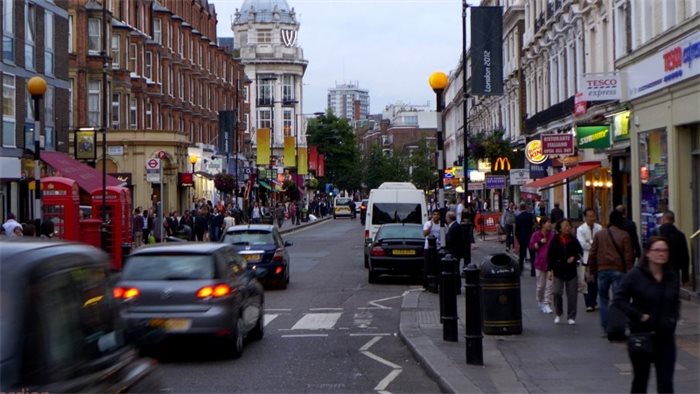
[625,32,700,100]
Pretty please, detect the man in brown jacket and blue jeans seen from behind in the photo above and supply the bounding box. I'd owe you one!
[588,210,634,332]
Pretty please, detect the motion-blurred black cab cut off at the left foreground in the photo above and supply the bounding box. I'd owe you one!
[0,241,160,393]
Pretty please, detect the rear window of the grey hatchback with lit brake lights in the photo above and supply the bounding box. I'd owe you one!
[122,254,216,280]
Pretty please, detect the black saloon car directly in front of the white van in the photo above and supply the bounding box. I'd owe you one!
[368,223,425,283]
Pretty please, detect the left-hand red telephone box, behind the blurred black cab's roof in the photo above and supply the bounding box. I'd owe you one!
[41,177,80,241]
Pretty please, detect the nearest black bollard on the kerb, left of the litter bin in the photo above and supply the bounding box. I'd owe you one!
[462,261,484,365]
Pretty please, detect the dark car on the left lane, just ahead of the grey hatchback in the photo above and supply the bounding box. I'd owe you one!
[221,224,292,289]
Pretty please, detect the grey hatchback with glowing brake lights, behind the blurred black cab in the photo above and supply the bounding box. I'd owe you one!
[114,242,265,358]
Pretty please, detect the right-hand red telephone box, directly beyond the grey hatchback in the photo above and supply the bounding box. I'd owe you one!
[92,186,132,271]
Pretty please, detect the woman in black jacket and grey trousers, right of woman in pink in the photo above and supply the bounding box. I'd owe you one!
[547,219,583,324]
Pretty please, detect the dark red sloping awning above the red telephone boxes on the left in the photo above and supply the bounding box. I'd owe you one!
[41,151,122,193]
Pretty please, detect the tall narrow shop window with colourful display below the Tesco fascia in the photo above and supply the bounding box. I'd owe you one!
[639,129,668,241]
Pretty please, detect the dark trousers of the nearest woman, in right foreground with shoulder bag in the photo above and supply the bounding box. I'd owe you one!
[628,335,676,393]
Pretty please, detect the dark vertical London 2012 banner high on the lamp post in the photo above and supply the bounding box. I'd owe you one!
[470,7,503,96]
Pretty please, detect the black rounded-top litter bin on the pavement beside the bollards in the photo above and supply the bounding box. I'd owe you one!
[481,253,523,335]
